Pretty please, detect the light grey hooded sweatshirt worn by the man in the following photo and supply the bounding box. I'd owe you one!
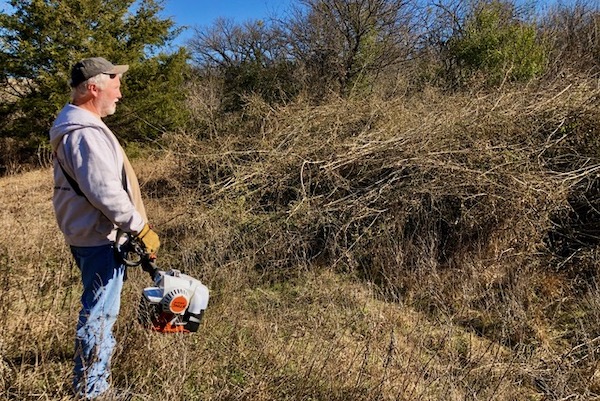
[50,104,145,247]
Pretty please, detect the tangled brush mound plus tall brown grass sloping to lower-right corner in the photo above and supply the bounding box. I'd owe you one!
[148,76,600,395]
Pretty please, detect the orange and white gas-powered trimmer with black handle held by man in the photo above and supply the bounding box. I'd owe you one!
[115,231,209,333]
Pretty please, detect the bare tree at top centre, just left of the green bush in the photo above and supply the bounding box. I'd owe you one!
[286,0,416,94]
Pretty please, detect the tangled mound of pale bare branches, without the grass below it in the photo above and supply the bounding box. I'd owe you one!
[172,78,598,282]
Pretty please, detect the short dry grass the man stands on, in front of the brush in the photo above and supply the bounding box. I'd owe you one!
[0,169,531,400]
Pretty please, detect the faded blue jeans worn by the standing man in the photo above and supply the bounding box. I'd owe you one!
[71,245,125,399]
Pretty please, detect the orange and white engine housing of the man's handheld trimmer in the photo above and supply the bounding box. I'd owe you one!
[139,270,208,333]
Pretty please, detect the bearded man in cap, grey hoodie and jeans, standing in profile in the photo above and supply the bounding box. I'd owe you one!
[50,57,160,400]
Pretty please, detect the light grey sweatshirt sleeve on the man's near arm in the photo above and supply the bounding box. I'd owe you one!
[65,127,144,233]
